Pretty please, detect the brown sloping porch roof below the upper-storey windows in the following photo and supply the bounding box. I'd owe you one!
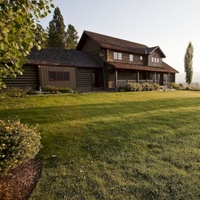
[106,62,178,73]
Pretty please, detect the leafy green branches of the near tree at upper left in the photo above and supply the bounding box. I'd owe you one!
[0,0,54,87]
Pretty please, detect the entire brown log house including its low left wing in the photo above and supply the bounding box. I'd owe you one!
[5,31,178,91]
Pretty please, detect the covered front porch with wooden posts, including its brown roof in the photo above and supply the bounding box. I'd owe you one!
[106,62,177,88]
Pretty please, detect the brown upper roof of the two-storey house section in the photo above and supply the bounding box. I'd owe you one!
[76,31,166,58]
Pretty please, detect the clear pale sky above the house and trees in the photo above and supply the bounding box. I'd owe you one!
[41,0,200,72]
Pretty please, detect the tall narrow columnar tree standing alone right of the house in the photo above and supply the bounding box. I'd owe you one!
[184,42,194,85]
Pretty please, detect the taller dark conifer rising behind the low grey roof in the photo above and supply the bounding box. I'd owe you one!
[47,7,65,48]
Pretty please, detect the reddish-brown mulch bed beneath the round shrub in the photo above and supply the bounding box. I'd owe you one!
[0,159,42,200]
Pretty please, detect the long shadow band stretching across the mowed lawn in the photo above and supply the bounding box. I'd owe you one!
[0,98,200,124]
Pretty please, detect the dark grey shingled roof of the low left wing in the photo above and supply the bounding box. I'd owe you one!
[26,47,99,68]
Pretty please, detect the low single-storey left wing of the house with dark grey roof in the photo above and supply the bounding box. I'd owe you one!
[5,47,102,91]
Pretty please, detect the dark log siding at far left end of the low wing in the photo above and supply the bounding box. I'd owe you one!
[3,65,39,90]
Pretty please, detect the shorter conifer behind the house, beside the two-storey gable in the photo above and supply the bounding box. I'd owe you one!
[66,24,79,49]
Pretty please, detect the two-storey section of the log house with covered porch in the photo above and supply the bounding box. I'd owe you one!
[77,31,178,88]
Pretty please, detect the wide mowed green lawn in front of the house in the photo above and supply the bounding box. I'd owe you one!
[0,91,200,200]
